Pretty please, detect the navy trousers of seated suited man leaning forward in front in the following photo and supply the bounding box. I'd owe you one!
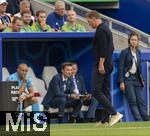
[50,97,83,117]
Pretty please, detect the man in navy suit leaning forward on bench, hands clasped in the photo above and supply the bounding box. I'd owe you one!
[42,62,82,123]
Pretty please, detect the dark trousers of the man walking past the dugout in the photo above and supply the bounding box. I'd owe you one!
[92,68,116,122]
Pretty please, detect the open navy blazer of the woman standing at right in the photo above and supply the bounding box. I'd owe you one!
[118,47,142,83]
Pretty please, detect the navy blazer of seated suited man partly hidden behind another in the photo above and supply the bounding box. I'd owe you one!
[75,74,86,94]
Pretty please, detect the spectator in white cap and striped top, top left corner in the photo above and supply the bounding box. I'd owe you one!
[0,0,11,32]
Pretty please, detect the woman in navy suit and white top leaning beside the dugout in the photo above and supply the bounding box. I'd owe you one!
[118,32,149,121]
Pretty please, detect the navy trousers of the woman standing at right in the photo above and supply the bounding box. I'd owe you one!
[125,75,149,121]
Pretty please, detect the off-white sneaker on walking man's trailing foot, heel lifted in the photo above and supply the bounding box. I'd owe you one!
[109,112,123,126]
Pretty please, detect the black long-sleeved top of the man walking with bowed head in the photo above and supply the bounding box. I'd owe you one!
[93,23,114,72]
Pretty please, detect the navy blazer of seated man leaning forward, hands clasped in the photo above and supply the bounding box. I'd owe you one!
[42,74,74,110]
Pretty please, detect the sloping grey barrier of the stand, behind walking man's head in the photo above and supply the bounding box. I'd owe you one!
[31,0,150,48]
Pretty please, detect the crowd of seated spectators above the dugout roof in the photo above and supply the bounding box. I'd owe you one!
[0,0,86,32]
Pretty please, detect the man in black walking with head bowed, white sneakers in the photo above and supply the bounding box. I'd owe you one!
[86,10,123,126]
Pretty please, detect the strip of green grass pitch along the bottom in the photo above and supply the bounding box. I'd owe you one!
[50,122,150,136]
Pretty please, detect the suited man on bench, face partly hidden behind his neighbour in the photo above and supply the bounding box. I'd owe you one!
[72,62,98,122]
